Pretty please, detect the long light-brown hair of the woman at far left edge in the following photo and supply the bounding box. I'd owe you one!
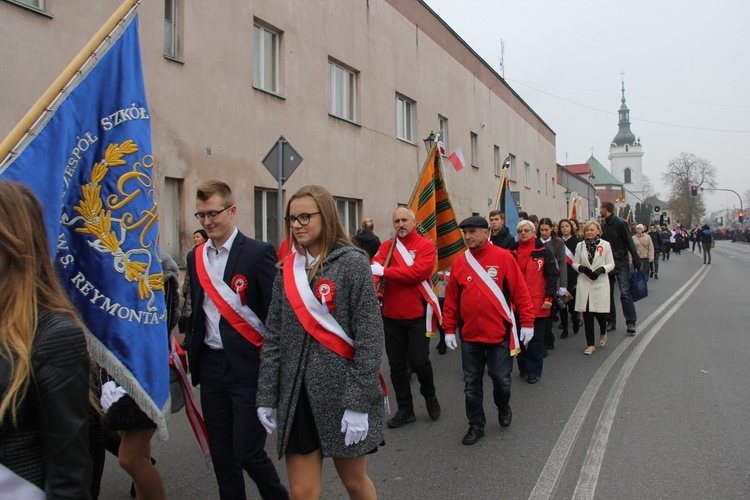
[0,180,78,424]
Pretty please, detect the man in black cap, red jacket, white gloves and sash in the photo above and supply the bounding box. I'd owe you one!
[443,216,534,445]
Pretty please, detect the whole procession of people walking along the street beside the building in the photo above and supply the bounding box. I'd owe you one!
[0,174,732,499]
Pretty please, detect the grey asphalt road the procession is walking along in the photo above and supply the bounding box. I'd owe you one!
[100,241,750,499]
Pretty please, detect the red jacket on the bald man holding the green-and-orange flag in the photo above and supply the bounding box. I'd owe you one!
[372,229,437,319]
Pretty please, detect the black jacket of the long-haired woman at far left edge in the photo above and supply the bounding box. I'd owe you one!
[0,312,93,499]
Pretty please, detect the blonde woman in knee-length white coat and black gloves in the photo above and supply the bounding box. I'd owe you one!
[573,221,615,354]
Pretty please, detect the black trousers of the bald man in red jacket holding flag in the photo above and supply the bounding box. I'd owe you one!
[383,317,435,411]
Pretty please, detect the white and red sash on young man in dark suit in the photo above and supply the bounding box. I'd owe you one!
[195,243,266,347]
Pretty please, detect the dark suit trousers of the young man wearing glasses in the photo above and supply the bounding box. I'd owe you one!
[200,345,289,500]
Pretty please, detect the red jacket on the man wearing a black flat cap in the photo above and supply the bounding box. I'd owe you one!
[443,242,534,344]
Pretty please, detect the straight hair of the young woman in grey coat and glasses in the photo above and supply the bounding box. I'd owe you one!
[286,184,353,277]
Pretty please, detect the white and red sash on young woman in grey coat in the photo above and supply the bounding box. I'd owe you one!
[284,249,354,361]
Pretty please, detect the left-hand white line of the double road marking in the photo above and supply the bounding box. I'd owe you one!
[529,267,708,500]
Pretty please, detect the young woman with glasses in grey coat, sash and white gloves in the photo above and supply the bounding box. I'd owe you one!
[256,186,384,498]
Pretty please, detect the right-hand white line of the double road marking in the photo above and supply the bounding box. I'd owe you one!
[573,268,708,500]
